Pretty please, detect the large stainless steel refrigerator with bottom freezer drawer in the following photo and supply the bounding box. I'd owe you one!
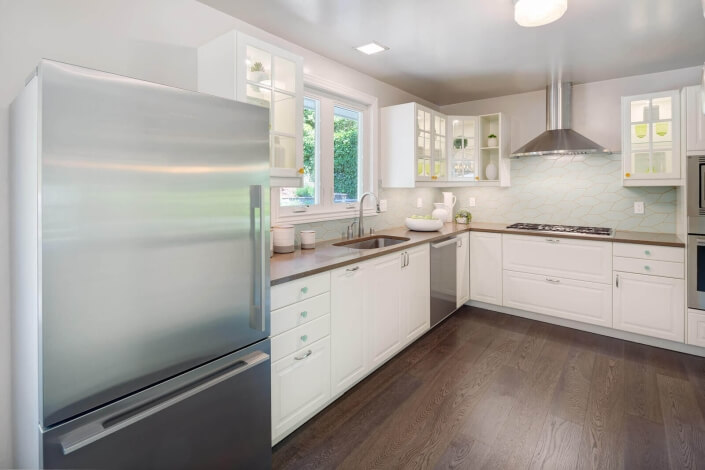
[10,60,271,469]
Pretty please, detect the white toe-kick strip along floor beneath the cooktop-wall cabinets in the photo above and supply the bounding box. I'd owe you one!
[465,300,705,357]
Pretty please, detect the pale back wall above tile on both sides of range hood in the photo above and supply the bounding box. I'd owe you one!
[440,67,702,153]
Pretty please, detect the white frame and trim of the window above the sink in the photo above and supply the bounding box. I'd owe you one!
[271,75,379,225]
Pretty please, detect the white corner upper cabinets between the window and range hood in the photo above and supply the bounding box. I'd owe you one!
[381,103,510,188]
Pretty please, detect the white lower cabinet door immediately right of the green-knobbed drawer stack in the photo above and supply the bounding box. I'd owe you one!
[331,263,372,396]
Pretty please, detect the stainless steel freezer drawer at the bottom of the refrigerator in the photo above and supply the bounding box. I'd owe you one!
[42,340,271,469]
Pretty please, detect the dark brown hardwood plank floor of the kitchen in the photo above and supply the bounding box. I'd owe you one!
[273,307,705,469]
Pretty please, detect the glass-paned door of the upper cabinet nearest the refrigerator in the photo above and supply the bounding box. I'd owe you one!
[238,35,303,178]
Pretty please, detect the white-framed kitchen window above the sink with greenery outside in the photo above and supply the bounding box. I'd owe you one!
[272,78,377,224]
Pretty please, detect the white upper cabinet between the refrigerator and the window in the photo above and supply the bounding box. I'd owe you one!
[198,31,304,186]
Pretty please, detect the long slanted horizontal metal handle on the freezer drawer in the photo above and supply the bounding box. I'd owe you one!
[61,351,269,455]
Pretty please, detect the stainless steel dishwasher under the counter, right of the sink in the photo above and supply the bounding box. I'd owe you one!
[431,237,459,327]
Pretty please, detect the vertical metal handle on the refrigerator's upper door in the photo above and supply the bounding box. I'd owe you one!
[250,185,268,331]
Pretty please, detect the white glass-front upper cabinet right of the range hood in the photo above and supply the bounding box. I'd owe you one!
[622,90,683,186]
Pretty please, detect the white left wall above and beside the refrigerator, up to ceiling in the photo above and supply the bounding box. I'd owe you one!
[0,0,429,468]
